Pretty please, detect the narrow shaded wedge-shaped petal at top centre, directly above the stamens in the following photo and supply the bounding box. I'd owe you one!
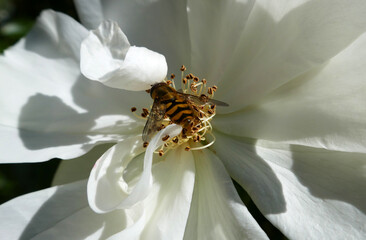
[187,0,255,85]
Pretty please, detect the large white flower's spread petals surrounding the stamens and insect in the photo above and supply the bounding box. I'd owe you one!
[0,0,366,239]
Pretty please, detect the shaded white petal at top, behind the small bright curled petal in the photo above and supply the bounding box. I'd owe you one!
[75,0,191,72]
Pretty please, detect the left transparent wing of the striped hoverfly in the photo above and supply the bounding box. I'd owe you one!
[142,99,166,142]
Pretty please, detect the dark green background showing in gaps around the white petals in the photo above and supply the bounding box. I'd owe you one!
[0,0,286,239]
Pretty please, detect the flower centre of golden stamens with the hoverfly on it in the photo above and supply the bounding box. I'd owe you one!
[131,66,223,156]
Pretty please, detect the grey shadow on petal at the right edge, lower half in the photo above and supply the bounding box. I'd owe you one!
[291,146,366,214]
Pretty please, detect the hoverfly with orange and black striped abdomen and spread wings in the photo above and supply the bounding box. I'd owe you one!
[142,82,229,142]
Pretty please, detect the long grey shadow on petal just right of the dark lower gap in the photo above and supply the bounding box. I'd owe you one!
[213,133,286,215]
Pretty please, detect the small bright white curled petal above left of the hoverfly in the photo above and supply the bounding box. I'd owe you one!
[80,21,167,91]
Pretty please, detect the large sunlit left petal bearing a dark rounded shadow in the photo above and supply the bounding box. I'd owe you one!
[0,10,149,162]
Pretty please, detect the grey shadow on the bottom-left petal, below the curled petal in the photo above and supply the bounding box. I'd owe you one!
[19,181,127,240]
